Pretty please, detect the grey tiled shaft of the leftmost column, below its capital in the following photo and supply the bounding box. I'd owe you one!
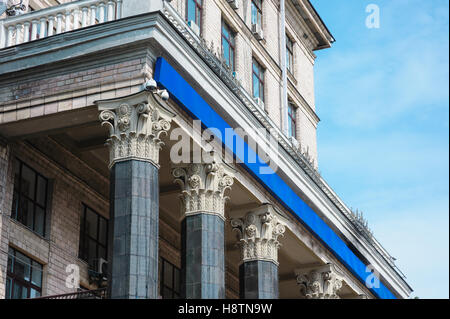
[110,160,159,299]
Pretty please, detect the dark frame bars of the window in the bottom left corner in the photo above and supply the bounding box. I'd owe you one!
[5,246,44,299]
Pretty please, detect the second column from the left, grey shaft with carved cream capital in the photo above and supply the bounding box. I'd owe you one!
[172,157,233,299]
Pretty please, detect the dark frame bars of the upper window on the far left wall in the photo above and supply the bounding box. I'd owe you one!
[11,158,49,238]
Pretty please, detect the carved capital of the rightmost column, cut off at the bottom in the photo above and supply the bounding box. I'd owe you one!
[296,264,343,299]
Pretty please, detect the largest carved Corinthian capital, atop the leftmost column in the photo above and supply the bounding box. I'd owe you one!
[95,86,173,166]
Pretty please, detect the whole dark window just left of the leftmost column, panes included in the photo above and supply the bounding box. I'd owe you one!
[78,205,108,269]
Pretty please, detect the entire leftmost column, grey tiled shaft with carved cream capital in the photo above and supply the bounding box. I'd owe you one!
[96,85,173,299]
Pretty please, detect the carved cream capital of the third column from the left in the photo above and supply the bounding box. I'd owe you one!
[231,205,285,264]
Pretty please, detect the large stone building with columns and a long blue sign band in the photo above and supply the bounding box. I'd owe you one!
[0,0,412,299]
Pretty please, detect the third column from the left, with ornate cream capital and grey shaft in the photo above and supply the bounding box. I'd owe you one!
[231,204,285,299]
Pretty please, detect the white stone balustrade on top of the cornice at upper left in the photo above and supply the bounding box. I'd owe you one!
[0,0,123,49]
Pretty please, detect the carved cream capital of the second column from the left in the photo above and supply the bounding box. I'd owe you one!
[172,159,234,219]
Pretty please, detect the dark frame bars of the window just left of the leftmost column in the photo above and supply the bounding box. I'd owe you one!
[78,203,110,267]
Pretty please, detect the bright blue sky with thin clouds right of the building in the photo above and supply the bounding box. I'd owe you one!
[311,0,449,298]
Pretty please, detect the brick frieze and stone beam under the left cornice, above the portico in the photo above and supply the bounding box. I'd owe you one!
[0,58,151,124]
